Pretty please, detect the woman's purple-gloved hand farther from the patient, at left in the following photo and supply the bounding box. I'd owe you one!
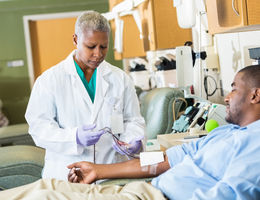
[76,124,105,146]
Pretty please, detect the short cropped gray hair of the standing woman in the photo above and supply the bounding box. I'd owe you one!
[75,10,110,37]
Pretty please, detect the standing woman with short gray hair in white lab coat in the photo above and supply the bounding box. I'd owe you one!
[25,11,144,180]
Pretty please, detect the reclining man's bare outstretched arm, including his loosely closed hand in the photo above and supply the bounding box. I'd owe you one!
[68,156,170,183]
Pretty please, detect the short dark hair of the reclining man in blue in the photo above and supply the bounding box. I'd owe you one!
[238,64,260,88]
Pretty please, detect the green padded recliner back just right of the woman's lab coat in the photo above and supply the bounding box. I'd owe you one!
[140,88,184,139]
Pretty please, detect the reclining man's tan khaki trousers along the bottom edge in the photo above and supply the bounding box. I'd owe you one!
[0,179,165,200]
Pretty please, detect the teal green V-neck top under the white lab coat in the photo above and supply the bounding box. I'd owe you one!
[74,60,97,103]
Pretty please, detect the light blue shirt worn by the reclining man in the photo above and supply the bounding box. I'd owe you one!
[152,120,260,200]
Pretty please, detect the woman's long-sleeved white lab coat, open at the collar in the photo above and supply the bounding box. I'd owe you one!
[25,52,144,180]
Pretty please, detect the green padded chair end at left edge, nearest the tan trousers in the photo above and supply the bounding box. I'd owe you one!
[0,145,45,190]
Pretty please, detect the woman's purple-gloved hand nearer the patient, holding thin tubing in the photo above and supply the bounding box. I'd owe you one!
[112,137,143,155]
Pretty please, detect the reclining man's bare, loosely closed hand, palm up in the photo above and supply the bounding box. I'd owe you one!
[68,161,98,184]
